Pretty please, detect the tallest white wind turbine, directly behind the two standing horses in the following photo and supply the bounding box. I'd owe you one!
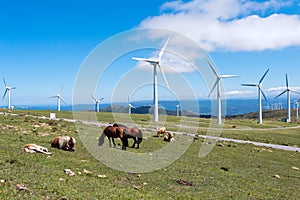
[132,39,169,122]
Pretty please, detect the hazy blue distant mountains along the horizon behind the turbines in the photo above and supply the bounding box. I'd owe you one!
[3,98,293,117]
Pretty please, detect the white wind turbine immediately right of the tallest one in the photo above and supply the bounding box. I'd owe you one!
[207,60,239,124]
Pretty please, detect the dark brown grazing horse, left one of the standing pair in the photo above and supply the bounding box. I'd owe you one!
[98,126,128,150]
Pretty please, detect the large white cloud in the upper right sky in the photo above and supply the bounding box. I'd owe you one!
[139,0,300,51]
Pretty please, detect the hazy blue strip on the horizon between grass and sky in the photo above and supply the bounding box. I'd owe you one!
[0,98,294,116]
